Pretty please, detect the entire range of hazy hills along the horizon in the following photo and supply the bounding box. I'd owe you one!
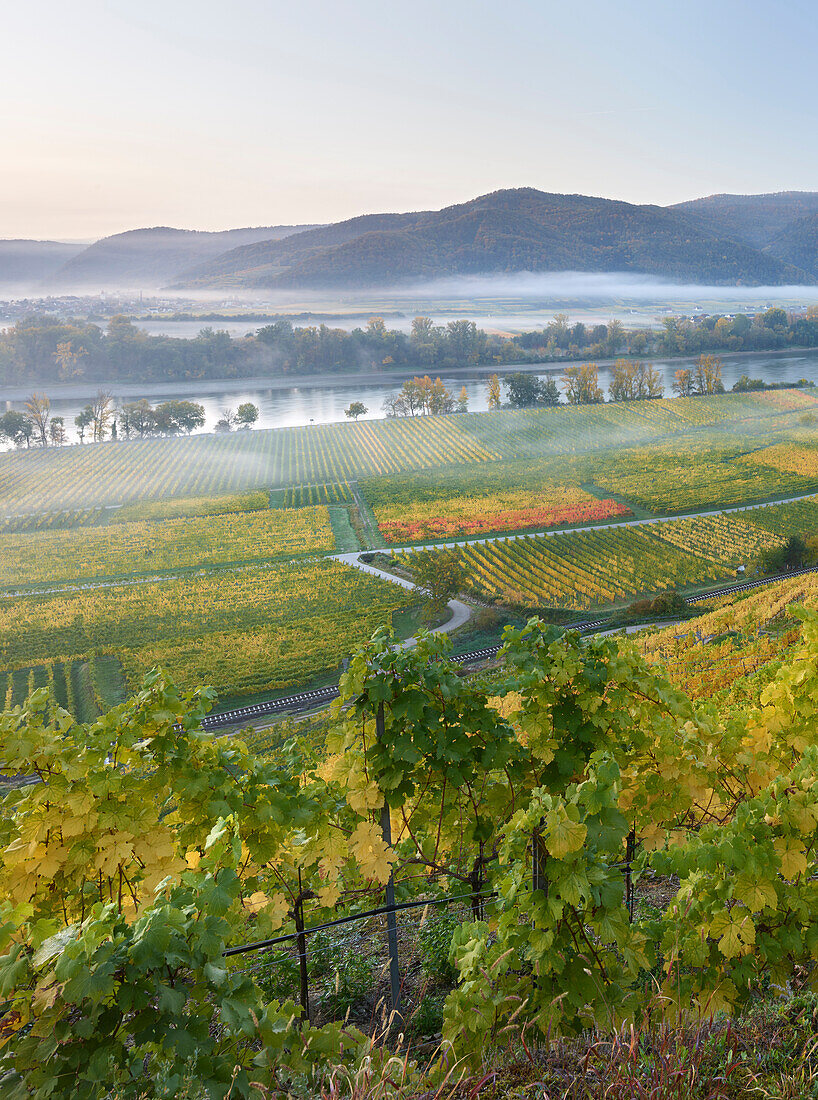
[6,187,818,293]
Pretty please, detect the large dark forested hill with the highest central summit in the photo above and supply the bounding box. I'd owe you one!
[179,188,814,287]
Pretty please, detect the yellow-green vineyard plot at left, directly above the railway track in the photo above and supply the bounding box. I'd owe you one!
[0,560,414,695]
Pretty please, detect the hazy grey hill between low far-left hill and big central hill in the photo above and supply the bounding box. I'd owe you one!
[48,226,321,289]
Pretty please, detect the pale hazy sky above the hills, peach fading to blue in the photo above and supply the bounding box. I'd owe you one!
[6,0,818,238]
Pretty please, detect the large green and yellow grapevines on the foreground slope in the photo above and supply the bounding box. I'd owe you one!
[7,607,818,1100]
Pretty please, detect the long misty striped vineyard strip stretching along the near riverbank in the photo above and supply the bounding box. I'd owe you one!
[0,391,816,514]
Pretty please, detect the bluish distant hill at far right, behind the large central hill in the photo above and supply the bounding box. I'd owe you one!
[667,191,818,248]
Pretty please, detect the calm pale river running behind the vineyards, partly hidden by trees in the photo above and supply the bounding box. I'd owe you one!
[0,349,818,441]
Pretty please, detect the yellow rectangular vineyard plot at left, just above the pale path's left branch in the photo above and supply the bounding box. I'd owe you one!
[0,506,335,587]
